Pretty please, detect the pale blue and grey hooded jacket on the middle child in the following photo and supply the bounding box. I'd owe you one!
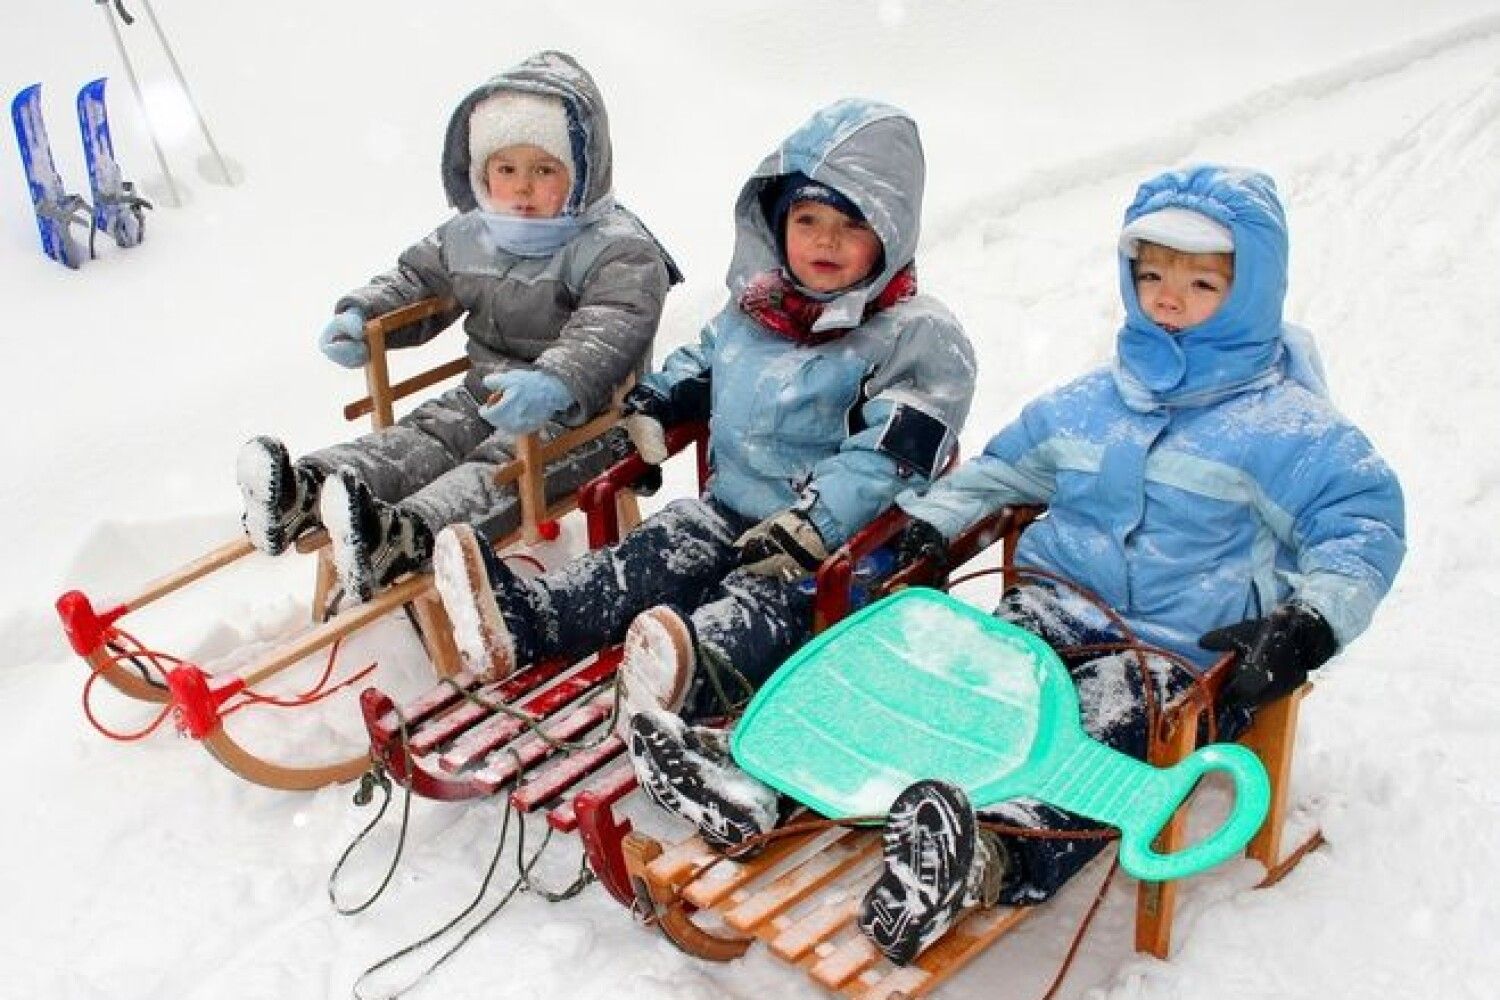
[647,100,975,547]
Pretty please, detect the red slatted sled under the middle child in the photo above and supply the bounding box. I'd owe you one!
[362,424,1032,909]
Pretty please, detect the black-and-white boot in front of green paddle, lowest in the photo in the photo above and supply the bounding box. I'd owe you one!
[858,781,1010,966]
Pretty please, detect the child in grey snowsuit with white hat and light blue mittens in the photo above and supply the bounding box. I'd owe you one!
[237,52,680,600]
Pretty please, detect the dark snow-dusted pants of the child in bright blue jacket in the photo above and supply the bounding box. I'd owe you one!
[983,585,1250,906]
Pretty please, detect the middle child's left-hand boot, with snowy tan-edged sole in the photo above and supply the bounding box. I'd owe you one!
[432,523,537,681]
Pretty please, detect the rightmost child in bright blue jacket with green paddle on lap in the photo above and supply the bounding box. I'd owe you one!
[633,166,1406,963]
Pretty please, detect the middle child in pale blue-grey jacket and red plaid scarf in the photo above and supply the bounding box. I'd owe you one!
[434,99,975,791]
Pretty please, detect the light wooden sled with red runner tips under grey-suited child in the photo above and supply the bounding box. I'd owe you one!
[57,298,639,790]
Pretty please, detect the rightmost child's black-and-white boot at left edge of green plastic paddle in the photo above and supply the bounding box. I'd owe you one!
[629,709,780,850]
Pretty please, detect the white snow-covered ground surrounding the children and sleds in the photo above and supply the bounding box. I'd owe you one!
[0,0,1500,1000]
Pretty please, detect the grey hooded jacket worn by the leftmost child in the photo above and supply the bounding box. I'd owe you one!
[335,52,678,424]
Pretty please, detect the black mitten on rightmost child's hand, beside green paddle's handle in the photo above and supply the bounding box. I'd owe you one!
[1199,601,1338,708]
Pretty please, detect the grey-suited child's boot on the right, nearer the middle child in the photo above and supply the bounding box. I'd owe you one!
[320,469,432,601]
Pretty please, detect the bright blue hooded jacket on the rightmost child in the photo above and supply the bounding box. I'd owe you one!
[902,166,1406,663]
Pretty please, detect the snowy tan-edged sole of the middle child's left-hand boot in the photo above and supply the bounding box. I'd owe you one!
[432,528,516,681]
